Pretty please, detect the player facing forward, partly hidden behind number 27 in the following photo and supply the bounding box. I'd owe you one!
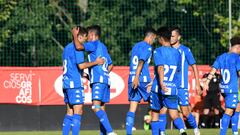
[171,27,201,135]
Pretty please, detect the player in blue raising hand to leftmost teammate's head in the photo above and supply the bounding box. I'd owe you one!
[72,25,116,135]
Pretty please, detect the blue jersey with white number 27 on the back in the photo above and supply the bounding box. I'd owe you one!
[152,46,181,95]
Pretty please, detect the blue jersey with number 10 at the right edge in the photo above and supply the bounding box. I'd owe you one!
[213,53,240,93]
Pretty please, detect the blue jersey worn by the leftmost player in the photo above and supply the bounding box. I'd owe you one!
[62,42,84,89]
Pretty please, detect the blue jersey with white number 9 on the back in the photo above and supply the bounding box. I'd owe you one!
[128,41,152,83]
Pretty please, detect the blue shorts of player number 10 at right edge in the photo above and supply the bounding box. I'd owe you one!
[222,93,238,109]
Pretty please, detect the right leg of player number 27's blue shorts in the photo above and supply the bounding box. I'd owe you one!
[161,95,178,110]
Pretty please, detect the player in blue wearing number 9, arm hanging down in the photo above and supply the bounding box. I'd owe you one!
[126,28,156,135]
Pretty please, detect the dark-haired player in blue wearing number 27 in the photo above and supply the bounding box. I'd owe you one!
[150,27,186,135]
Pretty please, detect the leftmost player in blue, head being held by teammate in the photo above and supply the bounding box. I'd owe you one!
[62,27,104,135]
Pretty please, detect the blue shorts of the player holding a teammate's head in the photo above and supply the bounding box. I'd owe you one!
[92,83,110,103]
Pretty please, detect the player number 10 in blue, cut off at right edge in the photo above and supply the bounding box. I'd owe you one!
[205,36,240,135]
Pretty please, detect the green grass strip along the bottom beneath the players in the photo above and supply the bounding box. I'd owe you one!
[0,129,238,135]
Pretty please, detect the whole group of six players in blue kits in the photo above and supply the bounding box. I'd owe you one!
[62,25,240,135]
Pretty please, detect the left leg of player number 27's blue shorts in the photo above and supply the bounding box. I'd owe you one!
[150,91,162,111]
